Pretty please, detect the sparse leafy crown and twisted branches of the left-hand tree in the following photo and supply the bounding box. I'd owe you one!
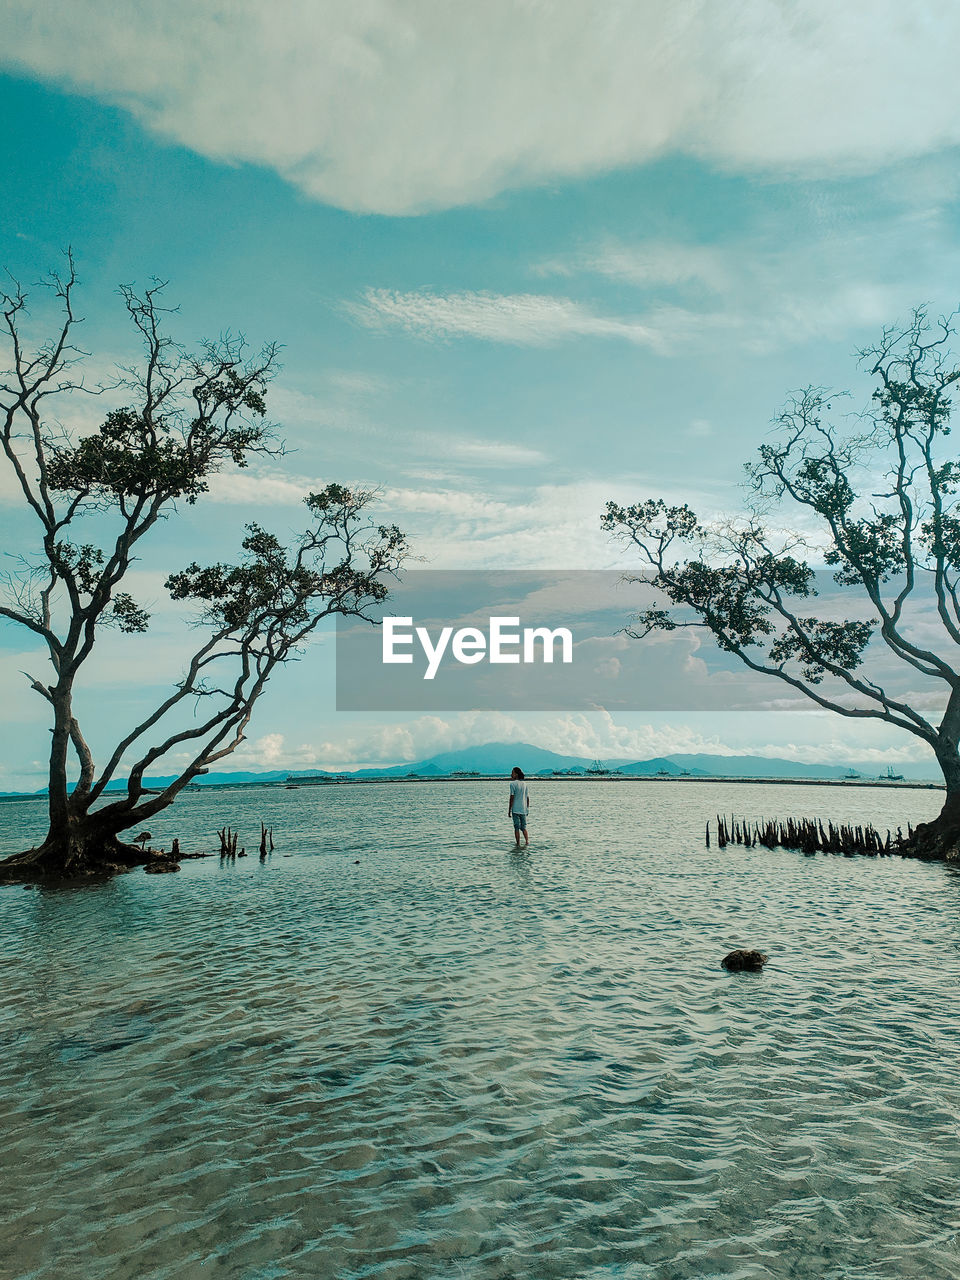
[0,257,406,861]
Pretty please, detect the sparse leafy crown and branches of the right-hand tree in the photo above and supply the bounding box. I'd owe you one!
[603,308,960,794]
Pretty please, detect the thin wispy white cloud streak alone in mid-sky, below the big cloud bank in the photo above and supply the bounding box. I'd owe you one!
[348,289,660,347]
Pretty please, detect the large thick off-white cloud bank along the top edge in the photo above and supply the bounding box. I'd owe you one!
[4,0,960,214]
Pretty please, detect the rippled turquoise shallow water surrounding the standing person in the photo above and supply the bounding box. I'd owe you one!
[0,782,960,1280]
